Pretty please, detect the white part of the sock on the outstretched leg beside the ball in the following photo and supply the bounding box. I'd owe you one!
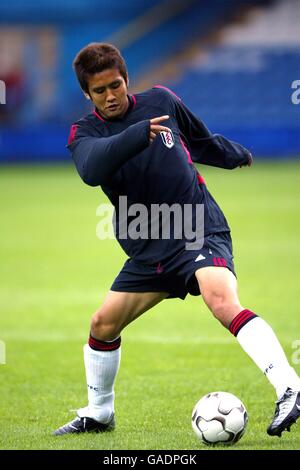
[237,317,300,398]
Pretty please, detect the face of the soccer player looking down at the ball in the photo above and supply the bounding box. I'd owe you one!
[88,69,128,119]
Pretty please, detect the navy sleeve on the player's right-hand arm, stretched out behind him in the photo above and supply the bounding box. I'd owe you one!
[173,98,251,170]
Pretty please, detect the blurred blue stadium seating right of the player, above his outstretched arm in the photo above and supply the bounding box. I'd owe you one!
[170,46,300,156]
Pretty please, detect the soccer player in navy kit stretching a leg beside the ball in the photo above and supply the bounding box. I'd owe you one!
[54,43,300,436]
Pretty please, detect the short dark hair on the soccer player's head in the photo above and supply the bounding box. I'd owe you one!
[73,42,128,93]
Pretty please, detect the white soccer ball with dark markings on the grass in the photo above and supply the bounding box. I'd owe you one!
[192,392,248,445]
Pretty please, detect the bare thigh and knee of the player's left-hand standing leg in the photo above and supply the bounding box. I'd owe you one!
[93,291,169,332]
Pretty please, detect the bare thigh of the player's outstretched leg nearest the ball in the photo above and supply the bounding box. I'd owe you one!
[195,266,240,310]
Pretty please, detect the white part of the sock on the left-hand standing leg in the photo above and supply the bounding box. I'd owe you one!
[77,344,121,423]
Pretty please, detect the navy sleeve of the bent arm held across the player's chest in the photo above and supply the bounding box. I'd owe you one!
[68,120,150,186]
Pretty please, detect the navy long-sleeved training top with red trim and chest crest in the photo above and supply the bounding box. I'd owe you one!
[68,86,251,265]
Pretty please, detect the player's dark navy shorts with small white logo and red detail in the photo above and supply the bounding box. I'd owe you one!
[111,232,235,299]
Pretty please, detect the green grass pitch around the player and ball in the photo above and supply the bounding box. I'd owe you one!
[0,162,300,450]
